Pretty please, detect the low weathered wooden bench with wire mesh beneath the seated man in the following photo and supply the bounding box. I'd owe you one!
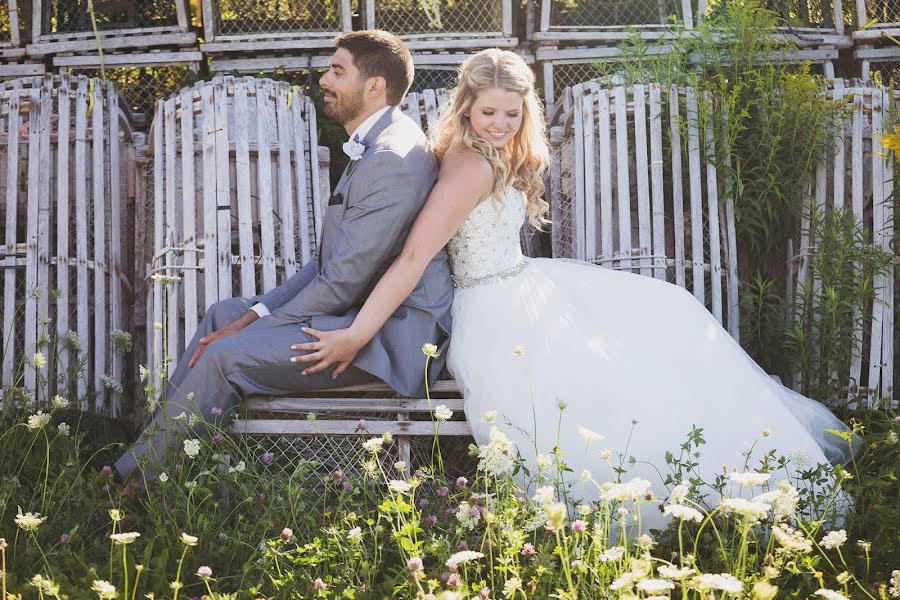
[232,380,473,474]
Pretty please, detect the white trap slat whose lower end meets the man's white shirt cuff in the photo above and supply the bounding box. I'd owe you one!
[234,82,256,298]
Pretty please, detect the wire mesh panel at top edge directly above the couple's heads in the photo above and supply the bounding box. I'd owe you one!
[375,0,502,35]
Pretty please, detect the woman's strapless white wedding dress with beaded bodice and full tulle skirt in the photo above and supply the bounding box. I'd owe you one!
[448,188,850,531]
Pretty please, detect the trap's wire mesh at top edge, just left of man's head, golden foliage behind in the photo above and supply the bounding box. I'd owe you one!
[213,0,343,35]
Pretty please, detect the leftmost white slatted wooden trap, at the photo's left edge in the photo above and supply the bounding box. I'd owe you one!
[0,75,135,415]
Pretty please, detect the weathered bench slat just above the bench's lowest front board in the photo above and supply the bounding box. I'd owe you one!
[244,398,465,413]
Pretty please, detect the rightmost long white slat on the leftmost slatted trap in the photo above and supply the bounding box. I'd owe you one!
[107,83,127,417]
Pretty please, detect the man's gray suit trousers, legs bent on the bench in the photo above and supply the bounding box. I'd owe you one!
[115,298,378,479]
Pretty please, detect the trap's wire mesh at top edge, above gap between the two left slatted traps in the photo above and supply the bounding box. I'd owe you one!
[42,0,180,34]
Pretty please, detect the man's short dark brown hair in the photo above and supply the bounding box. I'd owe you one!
[334,29,414,106]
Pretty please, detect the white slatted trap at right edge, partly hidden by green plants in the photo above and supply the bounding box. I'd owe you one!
[787,80,900,403]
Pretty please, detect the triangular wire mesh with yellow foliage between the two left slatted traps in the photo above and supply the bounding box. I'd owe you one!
[69,64,197,125]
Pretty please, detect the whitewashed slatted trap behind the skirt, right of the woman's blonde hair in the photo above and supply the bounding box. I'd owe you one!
[549,82,739,339]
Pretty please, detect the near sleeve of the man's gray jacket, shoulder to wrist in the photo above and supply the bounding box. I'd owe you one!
[273,150,418,321]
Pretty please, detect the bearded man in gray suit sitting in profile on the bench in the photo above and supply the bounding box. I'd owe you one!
[116,30,453,477]
